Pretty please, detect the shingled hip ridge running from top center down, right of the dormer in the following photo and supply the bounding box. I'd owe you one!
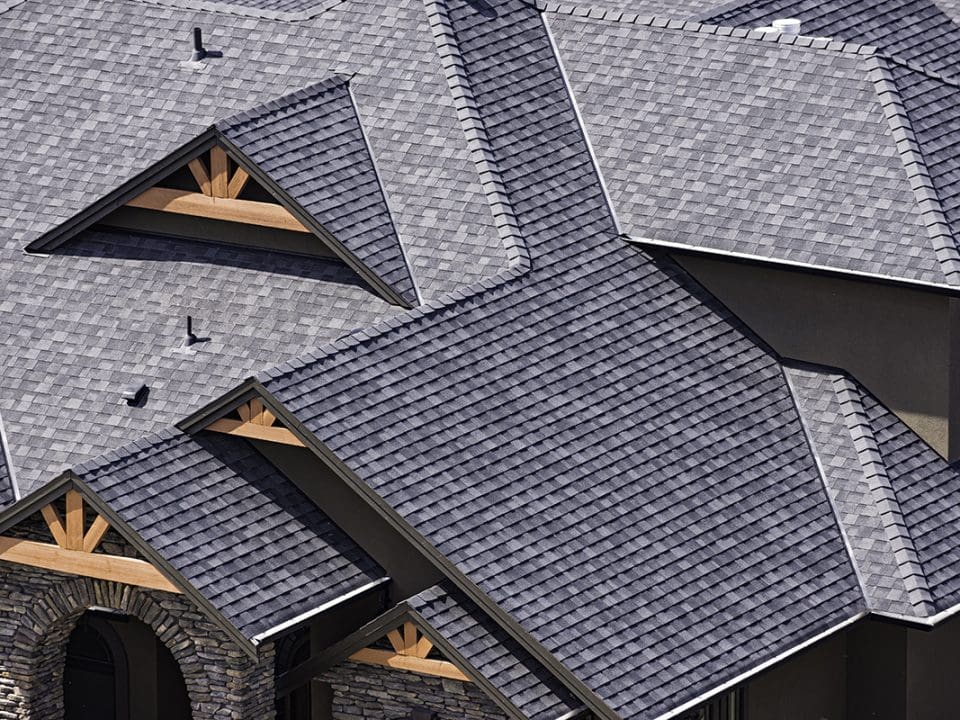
[424,0,530,272]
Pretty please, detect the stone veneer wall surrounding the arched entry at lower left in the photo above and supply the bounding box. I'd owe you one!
[0,562,275,720]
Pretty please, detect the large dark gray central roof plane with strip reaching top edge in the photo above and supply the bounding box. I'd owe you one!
[263,0,864,718]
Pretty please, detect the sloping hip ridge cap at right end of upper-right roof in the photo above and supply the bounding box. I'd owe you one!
[866,54,960,279]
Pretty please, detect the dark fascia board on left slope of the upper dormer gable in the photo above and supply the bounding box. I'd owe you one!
[24,127,216,253]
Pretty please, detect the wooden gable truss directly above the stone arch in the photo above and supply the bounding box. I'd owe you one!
[0,490,180,593]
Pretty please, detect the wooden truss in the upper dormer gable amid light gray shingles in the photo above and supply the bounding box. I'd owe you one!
[127,146,310,232]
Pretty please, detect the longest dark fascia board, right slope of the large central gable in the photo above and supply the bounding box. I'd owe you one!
[218,381,620,720]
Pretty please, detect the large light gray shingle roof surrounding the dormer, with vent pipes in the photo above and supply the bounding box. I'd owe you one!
[0,0,507,490]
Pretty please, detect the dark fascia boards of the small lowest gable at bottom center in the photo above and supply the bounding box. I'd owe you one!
[276,601,527,720]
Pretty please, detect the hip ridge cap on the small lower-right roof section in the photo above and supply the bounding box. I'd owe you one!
[833,374,936,614]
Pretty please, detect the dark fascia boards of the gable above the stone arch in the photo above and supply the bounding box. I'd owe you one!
[0,470,258,660]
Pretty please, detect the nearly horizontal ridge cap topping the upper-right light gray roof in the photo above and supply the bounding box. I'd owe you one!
[535,0,879,55]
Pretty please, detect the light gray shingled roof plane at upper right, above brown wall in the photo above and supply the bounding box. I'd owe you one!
[550,14,955,284]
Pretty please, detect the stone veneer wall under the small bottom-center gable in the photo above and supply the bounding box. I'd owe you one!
[318,662,507,720]
